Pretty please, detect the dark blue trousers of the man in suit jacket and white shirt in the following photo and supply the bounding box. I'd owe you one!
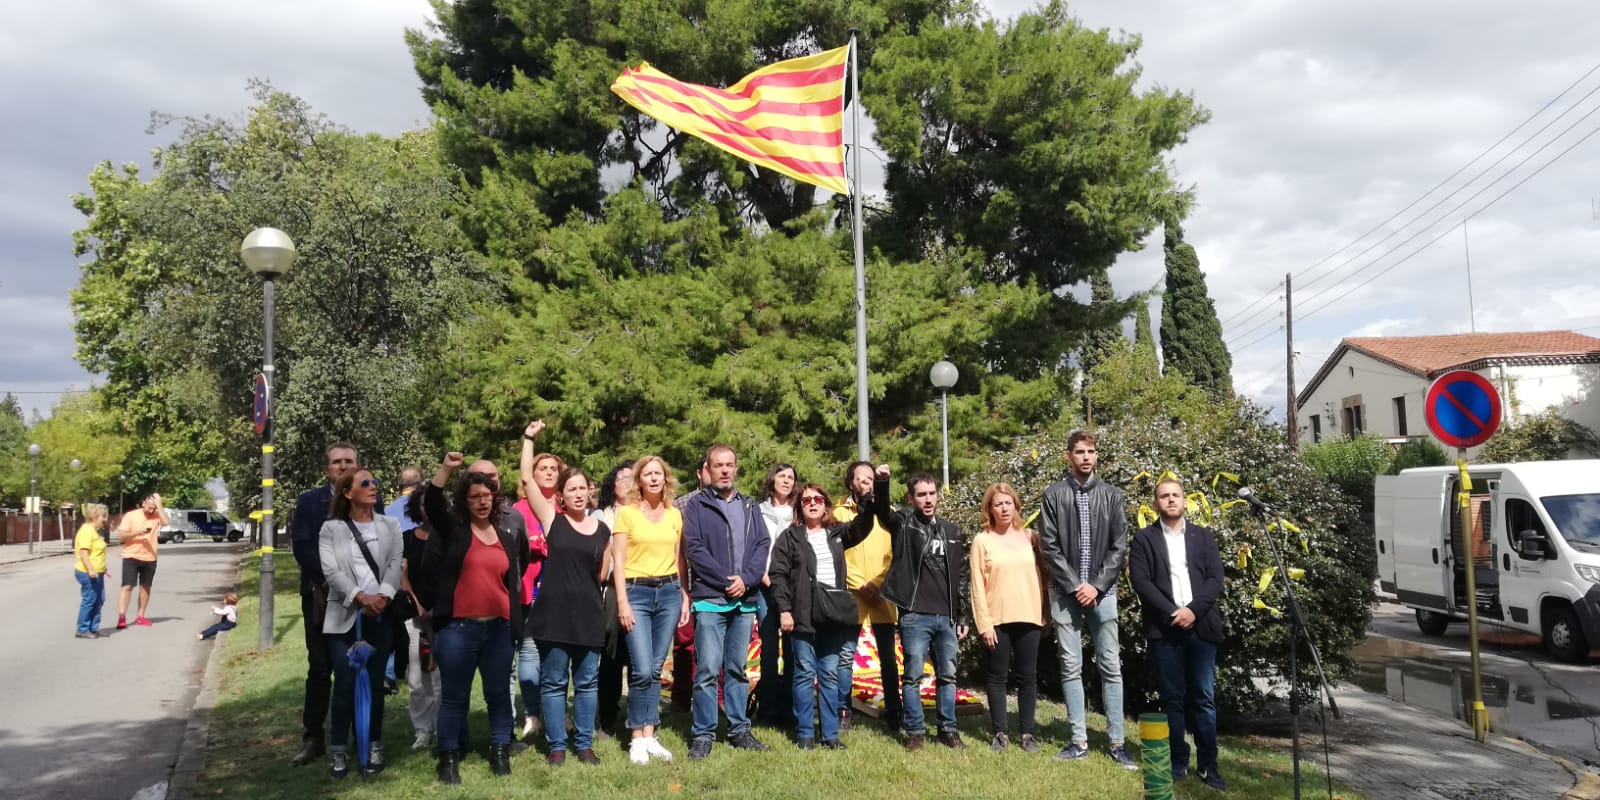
[1150,630,1216,773]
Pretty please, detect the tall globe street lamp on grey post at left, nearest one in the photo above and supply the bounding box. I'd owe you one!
[238,227,296,650]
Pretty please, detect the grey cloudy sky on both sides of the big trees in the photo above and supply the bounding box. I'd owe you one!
[0,0,1600,413]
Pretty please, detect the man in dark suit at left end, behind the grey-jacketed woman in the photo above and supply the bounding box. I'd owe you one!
[291,442,360,766]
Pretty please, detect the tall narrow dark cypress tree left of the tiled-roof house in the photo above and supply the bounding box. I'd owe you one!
[1162,222,1234,394]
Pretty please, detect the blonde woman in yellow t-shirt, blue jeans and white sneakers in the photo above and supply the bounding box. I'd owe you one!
[611,456,690,763]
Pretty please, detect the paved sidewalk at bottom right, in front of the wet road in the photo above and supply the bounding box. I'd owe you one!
[1301,685,1600,800]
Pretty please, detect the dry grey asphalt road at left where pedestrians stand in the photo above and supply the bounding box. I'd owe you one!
[0,542,245,800]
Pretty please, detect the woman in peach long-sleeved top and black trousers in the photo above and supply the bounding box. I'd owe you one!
[970,483,1045,752]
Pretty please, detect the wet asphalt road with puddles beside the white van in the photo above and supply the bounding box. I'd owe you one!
[1350,603,1600,766]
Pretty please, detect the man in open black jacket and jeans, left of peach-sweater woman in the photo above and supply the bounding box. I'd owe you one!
[867,466,970,750]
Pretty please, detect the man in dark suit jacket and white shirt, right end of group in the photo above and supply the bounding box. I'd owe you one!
[1128,478,1227,790]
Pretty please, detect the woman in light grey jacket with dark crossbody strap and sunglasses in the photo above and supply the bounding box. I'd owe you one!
[317,467,405,778]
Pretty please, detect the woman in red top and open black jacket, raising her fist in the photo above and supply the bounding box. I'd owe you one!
[418,453,530,786]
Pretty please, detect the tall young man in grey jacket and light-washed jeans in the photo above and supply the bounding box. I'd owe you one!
[1040,430,1139,770]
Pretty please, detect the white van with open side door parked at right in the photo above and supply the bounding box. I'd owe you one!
[1374,461,1600,661]
